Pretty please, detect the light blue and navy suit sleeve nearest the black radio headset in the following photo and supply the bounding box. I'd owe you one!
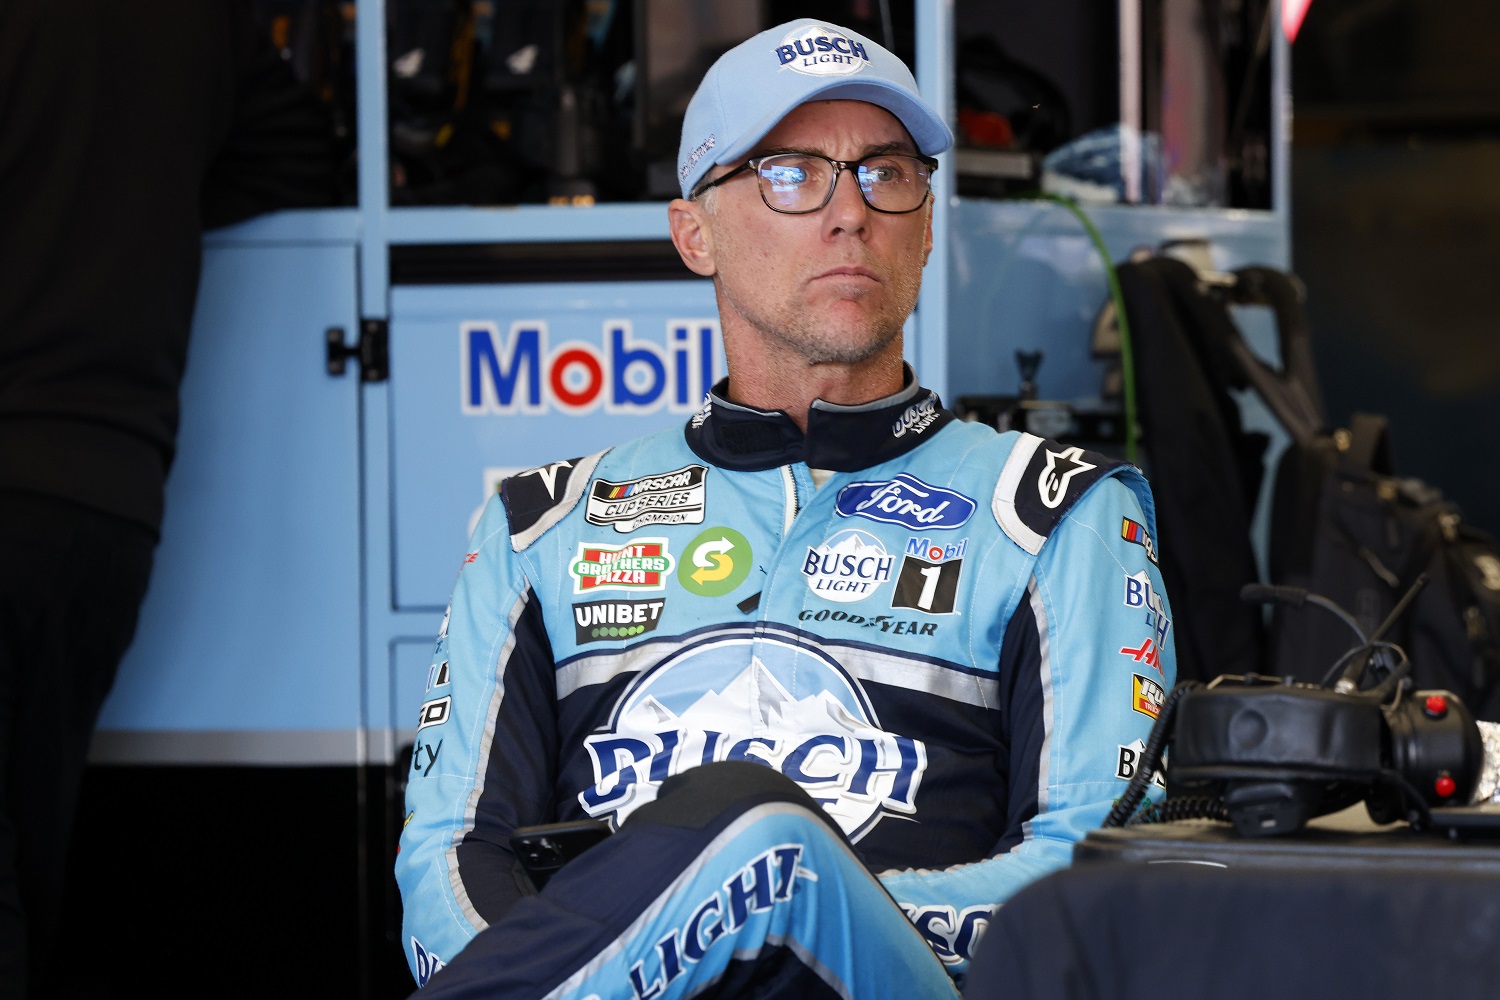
[881,477,1176,978]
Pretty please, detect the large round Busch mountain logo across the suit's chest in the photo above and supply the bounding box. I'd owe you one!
[578,630,927,841]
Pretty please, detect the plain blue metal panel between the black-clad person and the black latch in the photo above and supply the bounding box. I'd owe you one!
[101,244,360,734]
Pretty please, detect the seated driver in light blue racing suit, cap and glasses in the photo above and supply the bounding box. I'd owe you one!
[396,19,1175,999]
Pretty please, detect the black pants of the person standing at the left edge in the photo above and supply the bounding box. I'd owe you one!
[0,493,156,997]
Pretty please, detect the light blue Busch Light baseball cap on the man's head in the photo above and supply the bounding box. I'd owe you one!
[677,18,953,198]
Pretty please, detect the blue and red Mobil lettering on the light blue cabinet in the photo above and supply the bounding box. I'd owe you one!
[459,318,719,415]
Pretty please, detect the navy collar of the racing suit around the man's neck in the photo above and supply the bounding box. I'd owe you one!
[684,364,956,472]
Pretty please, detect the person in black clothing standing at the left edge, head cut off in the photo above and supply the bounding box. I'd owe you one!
[0,0,333,997]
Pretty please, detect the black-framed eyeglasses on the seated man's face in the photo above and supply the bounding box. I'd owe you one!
[692,153,938,216]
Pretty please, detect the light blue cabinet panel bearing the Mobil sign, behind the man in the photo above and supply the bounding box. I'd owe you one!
[390,280,723,609]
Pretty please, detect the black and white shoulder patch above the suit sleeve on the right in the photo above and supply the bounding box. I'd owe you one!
[990,433,1134,555]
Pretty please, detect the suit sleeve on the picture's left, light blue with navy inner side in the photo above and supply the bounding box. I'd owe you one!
[396,496,558,985]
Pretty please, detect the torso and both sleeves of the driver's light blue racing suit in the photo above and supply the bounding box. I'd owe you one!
[396,370,1175,997]
